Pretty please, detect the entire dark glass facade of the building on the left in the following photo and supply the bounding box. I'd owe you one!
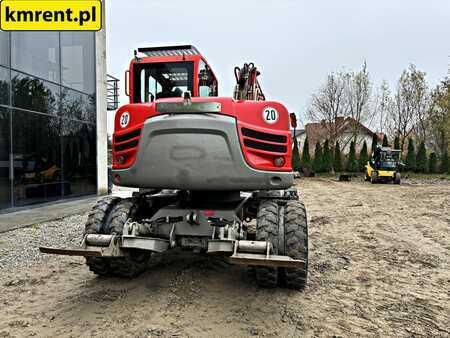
[0,31,97,211]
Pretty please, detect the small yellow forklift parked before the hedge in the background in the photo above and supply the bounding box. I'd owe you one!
[365,146,402,184]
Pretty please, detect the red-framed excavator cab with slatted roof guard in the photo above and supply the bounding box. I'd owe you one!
[125,45,218,103]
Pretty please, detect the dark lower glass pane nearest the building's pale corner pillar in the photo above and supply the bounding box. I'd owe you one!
[62,120,97,196]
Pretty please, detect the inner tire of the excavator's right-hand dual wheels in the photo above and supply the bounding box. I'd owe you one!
[255,200,279,288]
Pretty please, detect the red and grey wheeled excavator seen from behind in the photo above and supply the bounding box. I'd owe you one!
[40,45,308,289]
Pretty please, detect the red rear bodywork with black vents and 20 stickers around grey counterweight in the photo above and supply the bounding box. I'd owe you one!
[113,97,292,171]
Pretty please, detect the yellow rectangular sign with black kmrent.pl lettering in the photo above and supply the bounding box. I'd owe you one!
[0,0,102,31]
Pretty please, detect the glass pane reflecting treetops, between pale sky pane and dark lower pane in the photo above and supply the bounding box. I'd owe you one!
[11,71,60,114]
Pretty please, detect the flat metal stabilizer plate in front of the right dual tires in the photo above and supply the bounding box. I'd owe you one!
[229,253,305,269]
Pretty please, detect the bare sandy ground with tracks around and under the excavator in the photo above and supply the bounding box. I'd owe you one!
[0,179,450,337]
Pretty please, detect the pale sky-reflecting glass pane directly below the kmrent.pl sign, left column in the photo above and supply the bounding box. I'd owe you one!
[11,32,60,83]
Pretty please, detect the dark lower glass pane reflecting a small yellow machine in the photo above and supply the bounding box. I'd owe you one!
[12,110,64,206]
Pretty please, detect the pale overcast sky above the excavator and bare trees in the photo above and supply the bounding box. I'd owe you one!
[107,0,450,132]
